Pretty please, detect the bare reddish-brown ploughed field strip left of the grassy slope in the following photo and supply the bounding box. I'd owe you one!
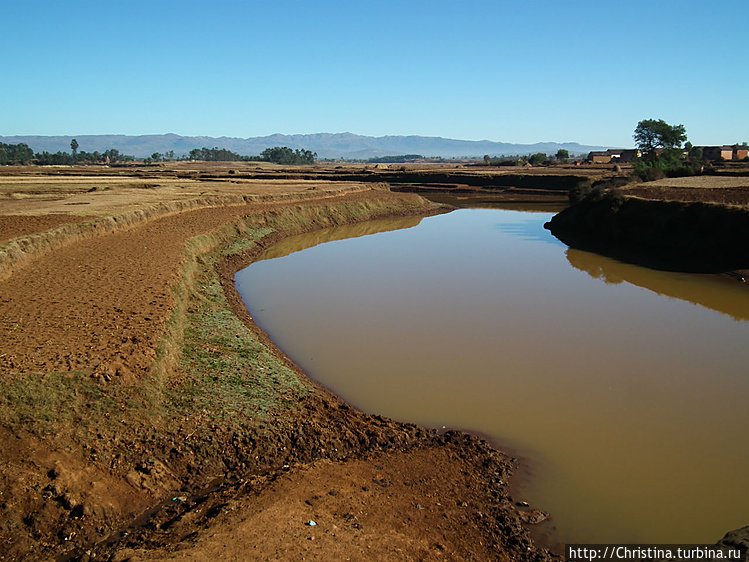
[0,201,262,376]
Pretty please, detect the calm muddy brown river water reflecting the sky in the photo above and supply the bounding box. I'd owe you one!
[236,209,749,544]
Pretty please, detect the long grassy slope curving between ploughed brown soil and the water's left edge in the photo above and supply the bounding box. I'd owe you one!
[150,198,438,423]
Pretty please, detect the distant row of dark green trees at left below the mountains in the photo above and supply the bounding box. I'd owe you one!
[0,139,317,166]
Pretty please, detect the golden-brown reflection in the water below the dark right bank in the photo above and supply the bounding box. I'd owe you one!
[566,248,749,321]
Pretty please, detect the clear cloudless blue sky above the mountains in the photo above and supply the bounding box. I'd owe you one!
[0,0,749,147]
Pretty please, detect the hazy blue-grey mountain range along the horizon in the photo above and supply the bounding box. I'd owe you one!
[0,133,612,160]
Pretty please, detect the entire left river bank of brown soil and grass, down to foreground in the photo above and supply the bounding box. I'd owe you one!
[0,180,546,560]
